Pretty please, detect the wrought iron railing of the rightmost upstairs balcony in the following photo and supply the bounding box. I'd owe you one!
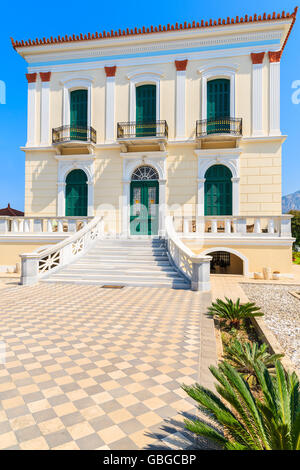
[196,117,243,138]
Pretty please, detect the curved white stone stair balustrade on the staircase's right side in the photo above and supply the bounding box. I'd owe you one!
[166,216,212,291]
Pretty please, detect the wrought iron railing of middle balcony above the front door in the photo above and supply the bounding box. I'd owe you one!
[117,121,168,139]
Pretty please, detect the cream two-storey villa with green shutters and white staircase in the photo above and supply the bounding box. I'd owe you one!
[0,9,297,290]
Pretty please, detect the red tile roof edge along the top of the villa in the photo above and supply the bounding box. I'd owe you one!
[11,7,298,50]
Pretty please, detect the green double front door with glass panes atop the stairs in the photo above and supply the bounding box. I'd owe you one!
[130,181,159,235]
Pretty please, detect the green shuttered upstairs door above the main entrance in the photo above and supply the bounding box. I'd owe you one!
[136,85,156,137]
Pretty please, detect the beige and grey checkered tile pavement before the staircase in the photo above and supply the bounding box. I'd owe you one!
[0,283,216,449]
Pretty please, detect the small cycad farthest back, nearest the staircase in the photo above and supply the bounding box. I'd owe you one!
[208,297,263,328]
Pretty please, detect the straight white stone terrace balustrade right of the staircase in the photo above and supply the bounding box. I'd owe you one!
[174,214,293,237]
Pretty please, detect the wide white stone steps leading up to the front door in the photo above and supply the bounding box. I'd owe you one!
[43,238,190,289]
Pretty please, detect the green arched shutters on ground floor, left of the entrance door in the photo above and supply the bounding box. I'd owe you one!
[66,170,87,217]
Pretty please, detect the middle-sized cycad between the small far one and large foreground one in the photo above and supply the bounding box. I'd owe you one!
[225,339,284,387]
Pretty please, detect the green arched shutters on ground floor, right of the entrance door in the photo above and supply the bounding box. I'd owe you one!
[204,165,232,215]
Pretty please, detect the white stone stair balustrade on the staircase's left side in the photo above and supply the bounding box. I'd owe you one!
[20,217,103,285]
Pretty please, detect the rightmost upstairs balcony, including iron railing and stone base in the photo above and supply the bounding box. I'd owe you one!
[196,117,243,146]
